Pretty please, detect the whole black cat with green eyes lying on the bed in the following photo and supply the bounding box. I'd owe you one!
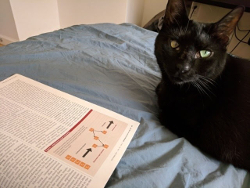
[155,0,250,171]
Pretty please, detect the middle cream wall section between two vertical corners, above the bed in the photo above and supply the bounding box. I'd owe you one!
[58,0,127,28]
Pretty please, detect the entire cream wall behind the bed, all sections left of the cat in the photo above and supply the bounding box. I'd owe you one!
[0,0,167,44]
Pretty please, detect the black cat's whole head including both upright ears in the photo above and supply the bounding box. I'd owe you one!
[155,0,242,84]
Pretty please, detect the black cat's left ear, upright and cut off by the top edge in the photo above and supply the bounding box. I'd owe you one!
[164,0,188,26]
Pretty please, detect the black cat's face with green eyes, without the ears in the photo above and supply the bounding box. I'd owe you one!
[155,21,226,84]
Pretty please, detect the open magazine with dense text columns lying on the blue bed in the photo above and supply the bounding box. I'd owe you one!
[0,74,139,188]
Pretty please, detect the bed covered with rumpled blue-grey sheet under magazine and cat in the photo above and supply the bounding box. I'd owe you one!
[0,23,250,188]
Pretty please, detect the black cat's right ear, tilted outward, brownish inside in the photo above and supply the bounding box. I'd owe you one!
[213,6,245,45]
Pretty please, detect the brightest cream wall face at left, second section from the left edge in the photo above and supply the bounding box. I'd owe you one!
[10,0,60,40]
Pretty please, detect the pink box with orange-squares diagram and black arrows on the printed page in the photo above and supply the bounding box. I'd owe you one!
[45,110,127,176]
